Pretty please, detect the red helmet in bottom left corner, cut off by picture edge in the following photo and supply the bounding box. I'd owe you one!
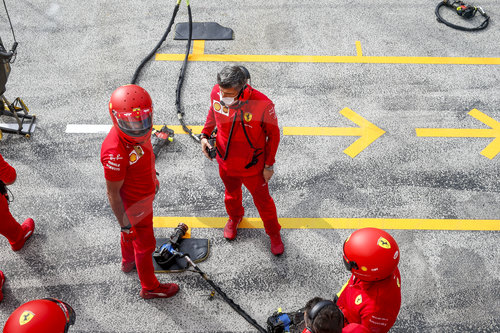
[3,298,76,333]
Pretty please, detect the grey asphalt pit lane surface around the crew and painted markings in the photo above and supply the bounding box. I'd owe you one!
[0,0,500,332]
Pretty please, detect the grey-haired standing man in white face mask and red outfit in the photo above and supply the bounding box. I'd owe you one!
[200,66,284,255]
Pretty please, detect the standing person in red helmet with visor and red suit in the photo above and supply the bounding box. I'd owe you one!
[101,84,179,298]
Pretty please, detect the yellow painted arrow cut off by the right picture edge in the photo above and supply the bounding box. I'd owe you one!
[415,109,500,160]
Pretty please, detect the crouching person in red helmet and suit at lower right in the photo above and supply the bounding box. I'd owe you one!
[337,228,401,333]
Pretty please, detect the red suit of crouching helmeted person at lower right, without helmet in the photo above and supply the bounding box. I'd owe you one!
[337,268,401,333]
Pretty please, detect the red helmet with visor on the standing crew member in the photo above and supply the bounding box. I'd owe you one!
[109,84,153,144]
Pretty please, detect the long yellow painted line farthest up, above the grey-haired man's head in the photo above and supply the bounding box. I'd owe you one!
[155,53,500,65]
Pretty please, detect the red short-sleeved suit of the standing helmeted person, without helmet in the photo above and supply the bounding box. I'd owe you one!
[101,126,159,290]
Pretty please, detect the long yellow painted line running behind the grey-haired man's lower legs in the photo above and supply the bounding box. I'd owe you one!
[153,216,500,231]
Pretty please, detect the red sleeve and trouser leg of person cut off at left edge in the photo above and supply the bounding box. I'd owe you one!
[0,154,23,244]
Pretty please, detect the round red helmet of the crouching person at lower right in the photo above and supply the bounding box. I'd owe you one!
[344,228,399,281]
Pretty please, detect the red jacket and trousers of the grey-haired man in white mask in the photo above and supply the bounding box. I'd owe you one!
[202,85,281,235]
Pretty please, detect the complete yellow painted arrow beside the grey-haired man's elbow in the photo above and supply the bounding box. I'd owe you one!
[283,108,385,158]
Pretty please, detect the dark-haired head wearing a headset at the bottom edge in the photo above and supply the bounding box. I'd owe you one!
[305,297,344,333]
